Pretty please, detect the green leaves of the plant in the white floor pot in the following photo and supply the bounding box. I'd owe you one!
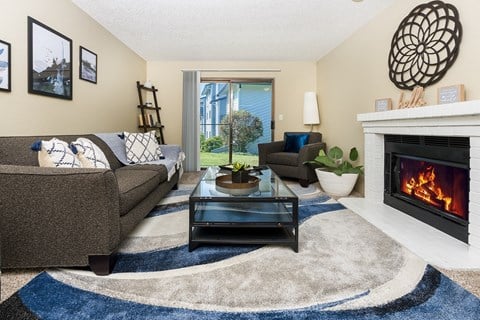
[305,146,363,176]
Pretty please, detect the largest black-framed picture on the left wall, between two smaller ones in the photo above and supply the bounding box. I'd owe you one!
[28,17,73,100]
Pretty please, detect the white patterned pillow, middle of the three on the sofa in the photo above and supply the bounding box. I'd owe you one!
[71,138,110,169]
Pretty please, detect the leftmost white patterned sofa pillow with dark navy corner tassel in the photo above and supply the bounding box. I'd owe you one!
[32,138,82,168]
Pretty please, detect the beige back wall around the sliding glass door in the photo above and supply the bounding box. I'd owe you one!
[147,61,317,144]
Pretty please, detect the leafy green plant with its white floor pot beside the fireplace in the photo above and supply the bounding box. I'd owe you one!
[306,146,363,197]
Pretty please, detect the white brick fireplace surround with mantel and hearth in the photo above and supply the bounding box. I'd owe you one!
[340,100,480,269]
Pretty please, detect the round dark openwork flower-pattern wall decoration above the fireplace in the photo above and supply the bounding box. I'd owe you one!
[388,1,463,90]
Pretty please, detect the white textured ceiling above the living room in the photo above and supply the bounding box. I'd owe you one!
[72,0,396,61]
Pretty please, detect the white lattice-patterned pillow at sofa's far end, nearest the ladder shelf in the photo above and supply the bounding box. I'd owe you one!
[124,131,164,163]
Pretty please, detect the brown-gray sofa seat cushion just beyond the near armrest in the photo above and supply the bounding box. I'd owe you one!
[115,166,162,216]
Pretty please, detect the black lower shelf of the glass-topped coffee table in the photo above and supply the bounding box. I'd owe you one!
[188,226,298,252]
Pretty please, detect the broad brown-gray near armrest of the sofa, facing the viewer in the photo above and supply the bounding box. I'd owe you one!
[0,165,120,268]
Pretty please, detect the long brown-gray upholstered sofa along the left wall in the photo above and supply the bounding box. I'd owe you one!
[0,135,180,275]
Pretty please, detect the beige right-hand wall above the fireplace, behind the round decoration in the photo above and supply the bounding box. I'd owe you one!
[317,0,480,190]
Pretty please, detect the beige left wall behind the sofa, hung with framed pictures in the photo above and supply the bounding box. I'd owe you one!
[0,0,146,135]
